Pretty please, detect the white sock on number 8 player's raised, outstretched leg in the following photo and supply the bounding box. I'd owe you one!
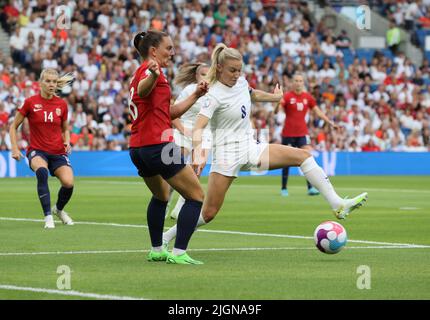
[300,157,343,209]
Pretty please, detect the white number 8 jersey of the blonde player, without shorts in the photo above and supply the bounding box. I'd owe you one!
[200,77,253,148]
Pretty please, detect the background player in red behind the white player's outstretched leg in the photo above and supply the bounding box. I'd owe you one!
[275,73,338,196]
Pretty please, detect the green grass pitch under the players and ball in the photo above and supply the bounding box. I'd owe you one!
[0,176,430,300]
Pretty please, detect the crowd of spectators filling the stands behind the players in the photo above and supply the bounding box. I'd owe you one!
[0,0,430,151]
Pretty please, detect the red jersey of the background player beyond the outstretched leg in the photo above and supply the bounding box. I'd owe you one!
[282,91,316,137]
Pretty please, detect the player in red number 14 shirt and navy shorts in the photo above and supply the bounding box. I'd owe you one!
[10,69,73,229]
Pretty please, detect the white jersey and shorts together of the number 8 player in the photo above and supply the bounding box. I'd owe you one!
[200,77,267,177]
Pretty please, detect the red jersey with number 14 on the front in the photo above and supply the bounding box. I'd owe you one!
[18,94,68,155]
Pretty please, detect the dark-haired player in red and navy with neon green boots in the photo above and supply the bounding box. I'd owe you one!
[129,30,208,264]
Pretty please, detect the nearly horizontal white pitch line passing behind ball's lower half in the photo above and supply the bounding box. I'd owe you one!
[0,245,430,256]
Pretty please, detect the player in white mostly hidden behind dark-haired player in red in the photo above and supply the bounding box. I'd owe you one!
[170,63,211,219]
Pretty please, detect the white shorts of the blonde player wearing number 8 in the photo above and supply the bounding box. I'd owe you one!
[210,140,269,177]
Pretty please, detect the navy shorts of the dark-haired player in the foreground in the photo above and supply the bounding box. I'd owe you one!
[129,142,185,180]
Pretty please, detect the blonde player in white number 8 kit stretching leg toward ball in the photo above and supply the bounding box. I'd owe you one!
[163,43,367,250]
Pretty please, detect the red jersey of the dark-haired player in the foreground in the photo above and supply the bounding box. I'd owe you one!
[129,61,173,147]
